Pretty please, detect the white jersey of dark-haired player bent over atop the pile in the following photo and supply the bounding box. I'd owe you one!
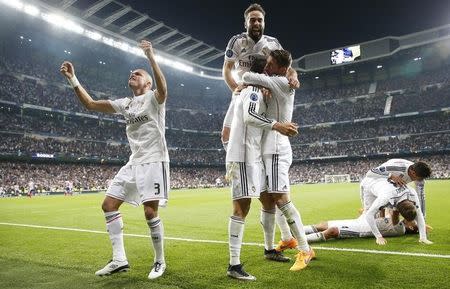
[366,159,414,183]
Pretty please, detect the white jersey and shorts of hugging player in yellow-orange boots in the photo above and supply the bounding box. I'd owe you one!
[242,72,295,193]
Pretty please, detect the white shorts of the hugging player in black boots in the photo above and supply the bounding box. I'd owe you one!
[227,162,265,200]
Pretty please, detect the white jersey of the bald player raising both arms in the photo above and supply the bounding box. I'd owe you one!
[110,90,169,165]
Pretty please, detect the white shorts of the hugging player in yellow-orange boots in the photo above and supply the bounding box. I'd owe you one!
[263,154,292,193]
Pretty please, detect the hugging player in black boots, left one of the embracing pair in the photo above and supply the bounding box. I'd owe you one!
[226,55,297,281]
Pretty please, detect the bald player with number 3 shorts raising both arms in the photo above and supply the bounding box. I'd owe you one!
[60,40,169,279]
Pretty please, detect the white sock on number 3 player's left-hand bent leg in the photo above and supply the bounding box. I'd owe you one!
[105,211,127,261]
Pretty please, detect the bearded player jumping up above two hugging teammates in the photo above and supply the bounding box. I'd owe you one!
[222,4,300,256]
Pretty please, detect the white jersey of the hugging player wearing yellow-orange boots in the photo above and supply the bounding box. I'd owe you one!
[242,72,295,155]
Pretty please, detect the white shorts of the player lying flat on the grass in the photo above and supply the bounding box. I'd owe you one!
[328,216,373,239]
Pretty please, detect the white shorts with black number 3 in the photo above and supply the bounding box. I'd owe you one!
[106,162,170,206]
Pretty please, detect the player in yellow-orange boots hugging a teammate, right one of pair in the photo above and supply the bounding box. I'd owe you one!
[242,50,314,271]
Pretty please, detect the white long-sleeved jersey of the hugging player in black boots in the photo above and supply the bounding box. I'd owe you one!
[226,86,275,163]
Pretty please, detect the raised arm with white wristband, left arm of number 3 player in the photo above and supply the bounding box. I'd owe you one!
[59,61,116,113]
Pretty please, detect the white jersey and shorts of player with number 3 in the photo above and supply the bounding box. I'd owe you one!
[106,90,170,205]
